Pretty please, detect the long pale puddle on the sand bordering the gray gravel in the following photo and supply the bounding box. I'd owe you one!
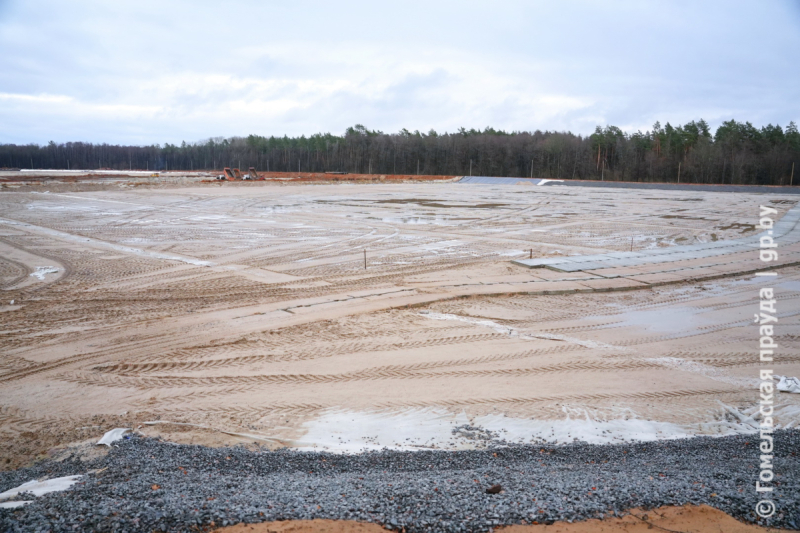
[287,404,800,453]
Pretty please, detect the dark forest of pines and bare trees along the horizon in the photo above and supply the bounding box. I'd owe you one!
[0,120,800,185]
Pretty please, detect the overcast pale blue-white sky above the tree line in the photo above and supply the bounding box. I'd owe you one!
[0,0,800,145]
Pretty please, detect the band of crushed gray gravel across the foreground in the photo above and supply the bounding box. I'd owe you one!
[0,428,800,532]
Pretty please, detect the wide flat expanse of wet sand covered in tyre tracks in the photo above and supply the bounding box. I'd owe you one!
[0,180,800,462]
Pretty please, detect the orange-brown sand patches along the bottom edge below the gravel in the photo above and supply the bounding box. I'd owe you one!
[216,505,779,533]
